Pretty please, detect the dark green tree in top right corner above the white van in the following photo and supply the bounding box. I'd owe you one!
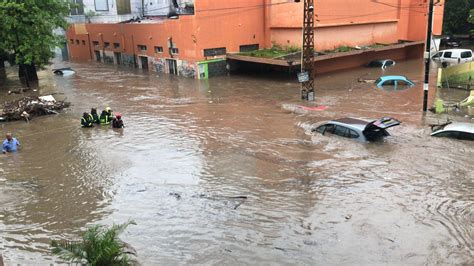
[443,0,474,34]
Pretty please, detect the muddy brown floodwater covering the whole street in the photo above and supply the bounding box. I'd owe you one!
[0,57,474,265]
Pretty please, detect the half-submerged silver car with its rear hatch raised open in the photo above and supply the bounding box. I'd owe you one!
[312,117,400,141]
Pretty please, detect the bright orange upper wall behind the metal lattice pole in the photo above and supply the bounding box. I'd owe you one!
[265,0,444,50]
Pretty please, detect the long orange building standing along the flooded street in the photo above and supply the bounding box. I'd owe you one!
[67,0,444,78]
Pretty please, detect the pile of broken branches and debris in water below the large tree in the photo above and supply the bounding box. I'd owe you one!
[0,97,71,121]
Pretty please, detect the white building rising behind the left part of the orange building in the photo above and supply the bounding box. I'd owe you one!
[68,0,194,23]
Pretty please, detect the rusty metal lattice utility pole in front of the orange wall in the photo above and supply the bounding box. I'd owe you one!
[298,0,314,101]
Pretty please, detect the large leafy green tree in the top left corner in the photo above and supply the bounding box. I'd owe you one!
[0,0,71,83]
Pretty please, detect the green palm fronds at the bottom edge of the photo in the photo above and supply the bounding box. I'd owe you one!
[51,221,136,266]
